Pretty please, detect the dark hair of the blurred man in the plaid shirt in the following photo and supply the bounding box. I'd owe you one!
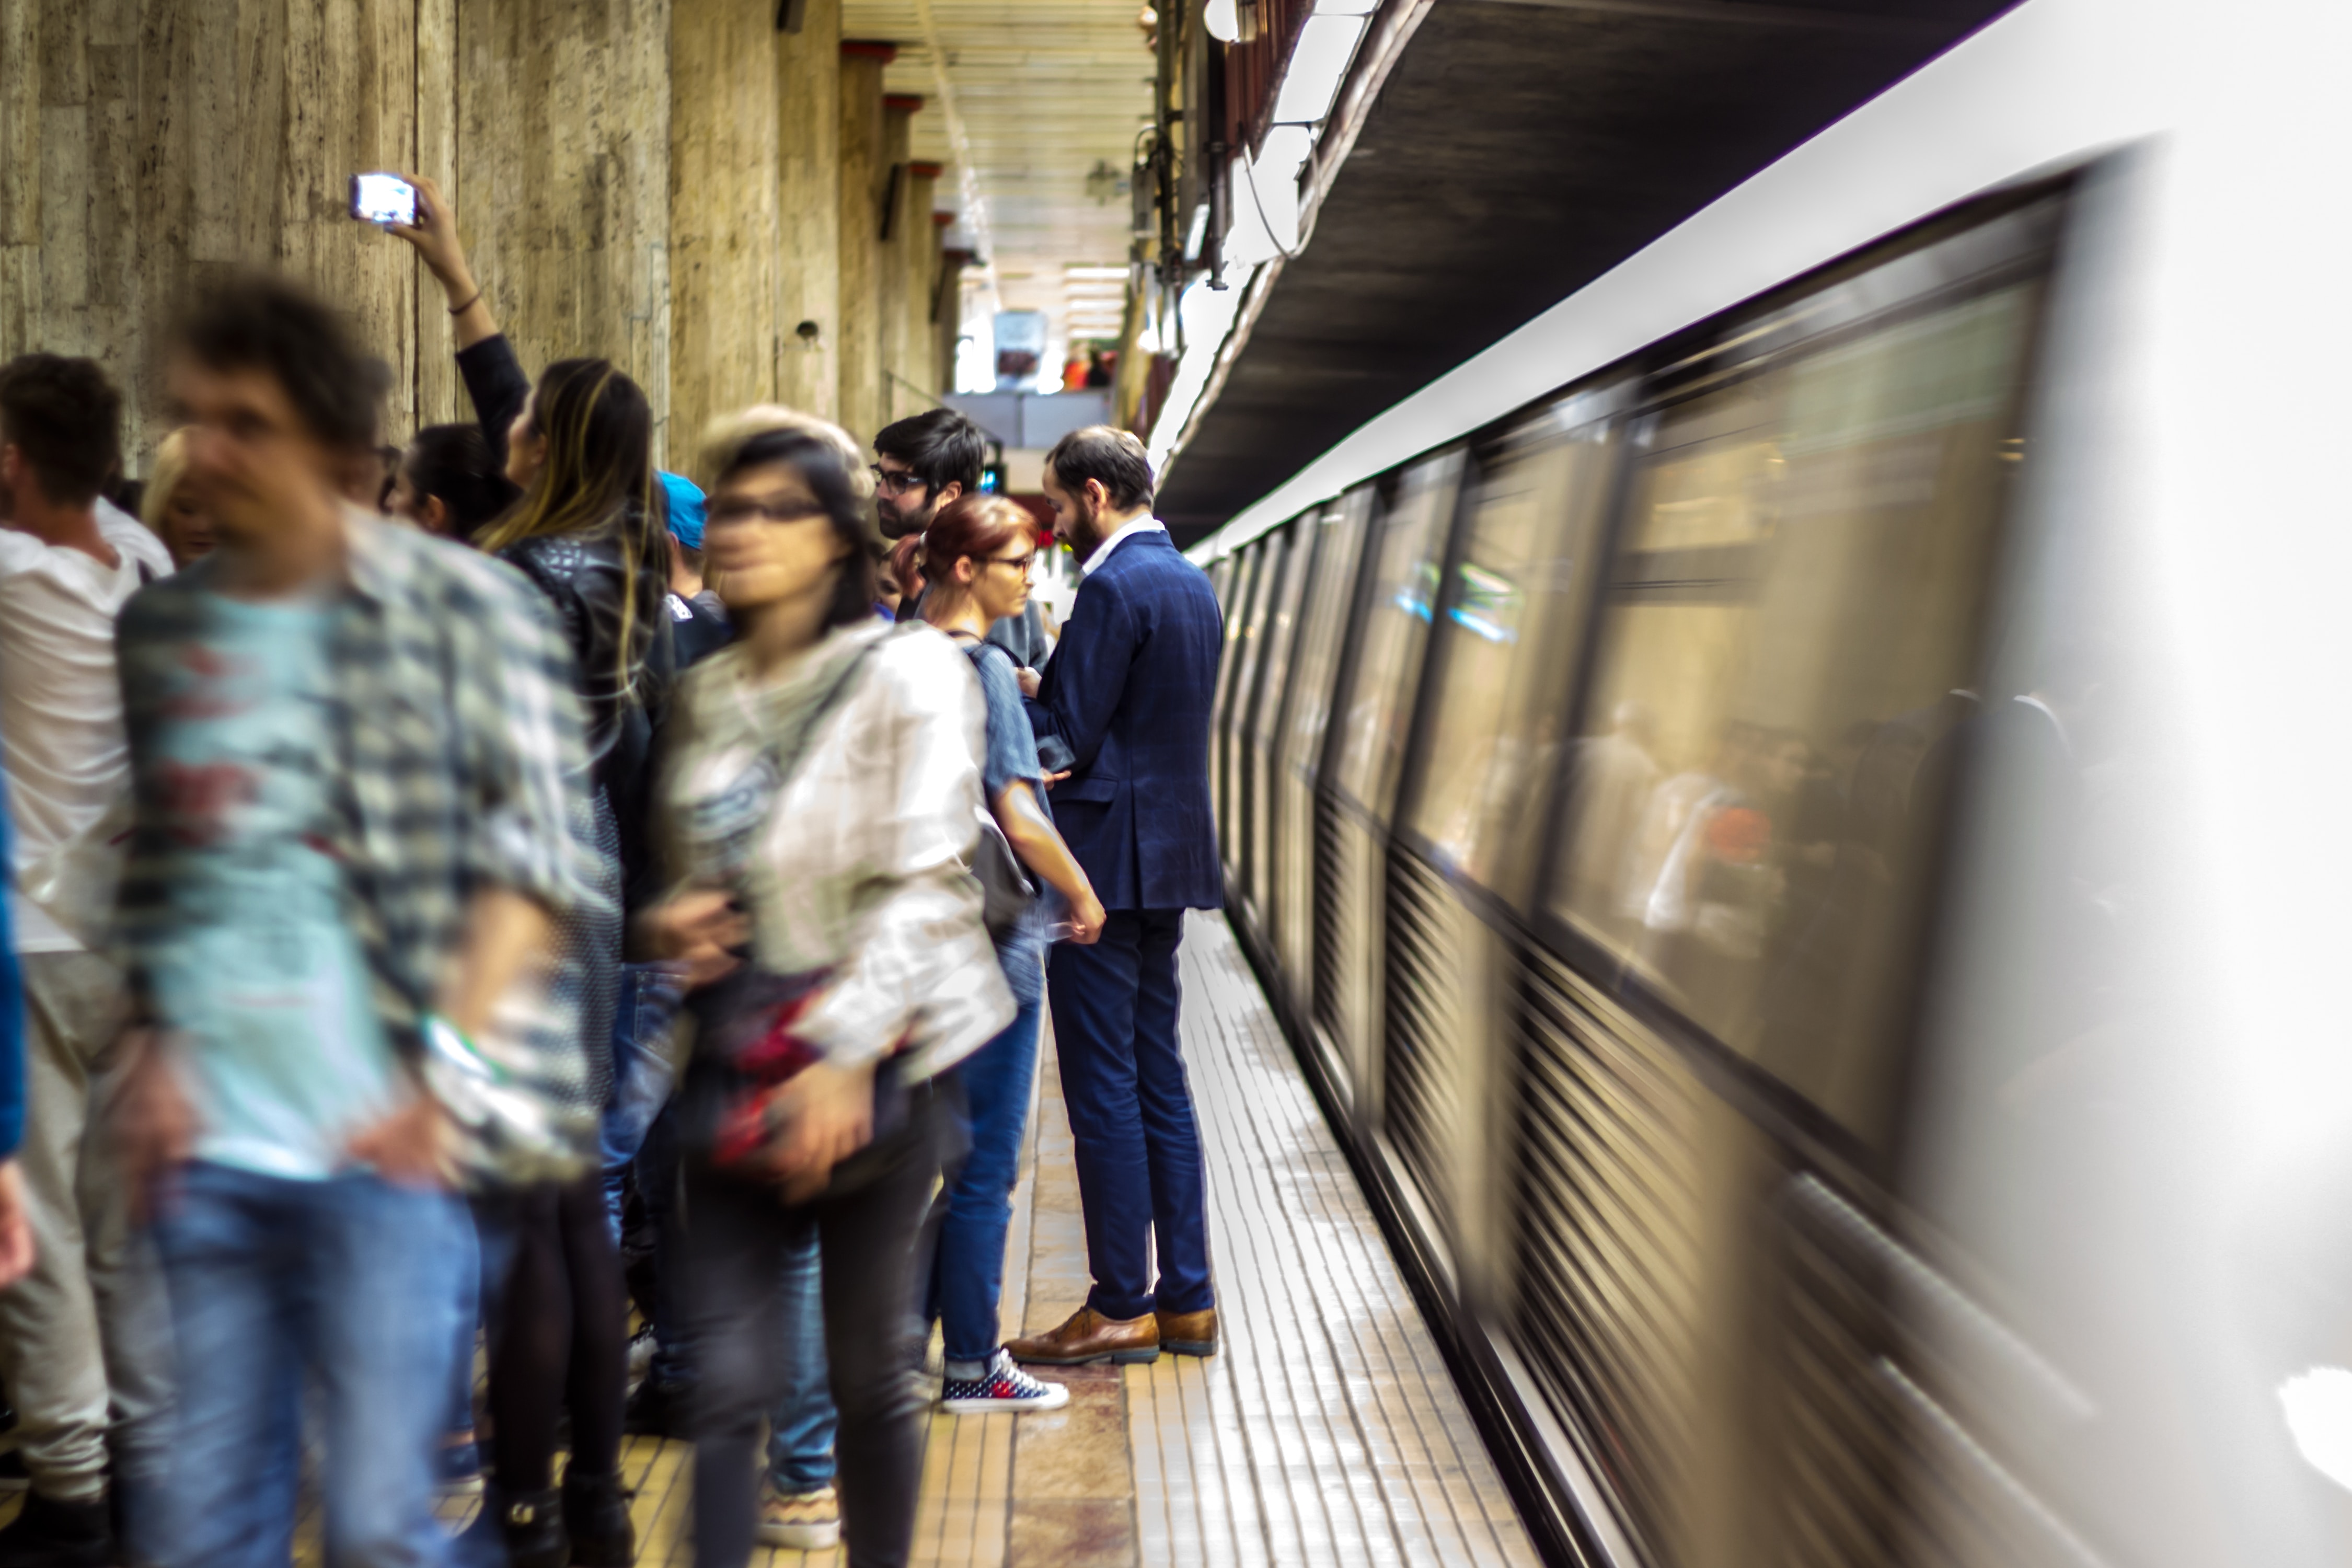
[172,273,390,452]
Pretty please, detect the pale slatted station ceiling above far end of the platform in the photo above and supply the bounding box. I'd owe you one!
[842,0,1155,355]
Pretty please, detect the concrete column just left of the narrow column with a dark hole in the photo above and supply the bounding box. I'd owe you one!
[671,0,779,468]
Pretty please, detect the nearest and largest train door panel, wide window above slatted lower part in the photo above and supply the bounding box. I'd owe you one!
[1510,196,2049,1568]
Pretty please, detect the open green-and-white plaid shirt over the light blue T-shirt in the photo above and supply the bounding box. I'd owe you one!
[116,510,595,1048]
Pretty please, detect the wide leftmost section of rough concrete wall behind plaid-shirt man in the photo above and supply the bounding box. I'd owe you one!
[0,0,417,472]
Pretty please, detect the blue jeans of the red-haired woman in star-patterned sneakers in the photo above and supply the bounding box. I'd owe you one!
[931,1001,1044,1361]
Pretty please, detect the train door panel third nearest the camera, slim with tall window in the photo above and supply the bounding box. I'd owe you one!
[1315,452,1463,1138]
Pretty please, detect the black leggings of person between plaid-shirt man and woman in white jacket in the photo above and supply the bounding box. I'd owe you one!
[489,1171,628,1495]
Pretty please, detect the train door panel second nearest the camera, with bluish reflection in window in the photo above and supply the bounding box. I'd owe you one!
[1381,386,1625,1300]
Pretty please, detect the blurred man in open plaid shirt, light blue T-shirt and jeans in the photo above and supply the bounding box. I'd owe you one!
[118,280,591,1568]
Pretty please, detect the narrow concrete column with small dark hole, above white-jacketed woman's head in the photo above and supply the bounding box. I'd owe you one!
[776,0,842,419]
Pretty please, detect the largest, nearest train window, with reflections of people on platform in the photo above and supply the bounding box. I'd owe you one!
[1552,282,2037,1143]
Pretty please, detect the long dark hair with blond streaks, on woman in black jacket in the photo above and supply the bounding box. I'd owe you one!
[473,360,668,694]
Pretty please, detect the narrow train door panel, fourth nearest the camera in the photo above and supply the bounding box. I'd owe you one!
[1273,496,1374,1048]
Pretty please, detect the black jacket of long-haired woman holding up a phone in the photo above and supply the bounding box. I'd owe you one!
[456,334,677,903]
